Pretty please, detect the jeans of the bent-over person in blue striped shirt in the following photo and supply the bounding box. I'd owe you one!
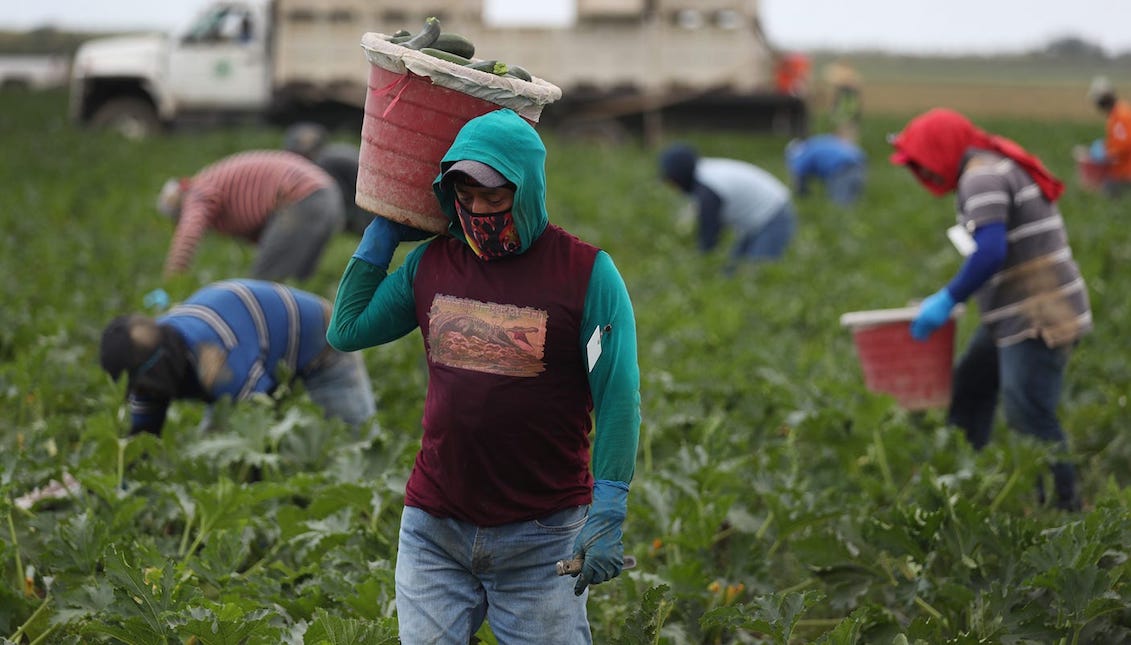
[302,352,377,428]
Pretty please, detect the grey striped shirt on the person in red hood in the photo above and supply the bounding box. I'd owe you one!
[957,153,1091,347]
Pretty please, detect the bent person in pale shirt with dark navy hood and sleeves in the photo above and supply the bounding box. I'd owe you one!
[659,144,796,275]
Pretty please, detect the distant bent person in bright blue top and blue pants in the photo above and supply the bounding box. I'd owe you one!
[785,135,867,206]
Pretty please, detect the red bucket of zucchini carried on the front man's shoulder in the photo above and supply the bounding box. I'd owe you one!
[355,33,561,233]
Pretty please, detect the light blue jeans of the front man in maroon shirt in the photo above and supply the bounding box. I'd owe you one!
[396,506,593,645]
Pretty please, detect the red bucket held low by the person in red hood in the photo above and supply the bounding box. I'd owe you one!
[840,307,956,411]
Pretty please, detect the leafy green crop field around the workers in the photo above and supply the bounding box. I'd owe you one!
[0,86,1131,645]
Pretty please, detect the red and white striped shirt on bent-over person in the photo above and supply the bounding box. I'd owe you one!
[165,151,334,274]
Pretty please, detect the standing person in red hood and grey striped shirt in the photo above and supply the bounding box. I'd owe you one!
[890,109,1093,510]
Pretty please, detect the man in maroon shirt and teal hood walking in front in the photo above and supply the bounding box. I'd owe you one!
[327,109,640,644]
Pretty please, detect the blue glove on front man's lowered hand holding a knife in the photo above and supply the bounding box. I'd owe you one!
[573,480,629,595]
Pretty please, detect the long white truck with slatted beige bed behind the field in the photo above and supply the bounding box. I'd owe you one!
[70,0,805,137]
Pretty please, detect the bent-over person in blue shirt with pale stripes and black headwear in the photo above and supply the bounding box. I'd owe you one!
[100,280,377,435]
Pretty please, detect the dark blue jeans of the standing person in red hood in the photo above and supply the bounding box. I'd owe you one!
[948,325,1076,499]
